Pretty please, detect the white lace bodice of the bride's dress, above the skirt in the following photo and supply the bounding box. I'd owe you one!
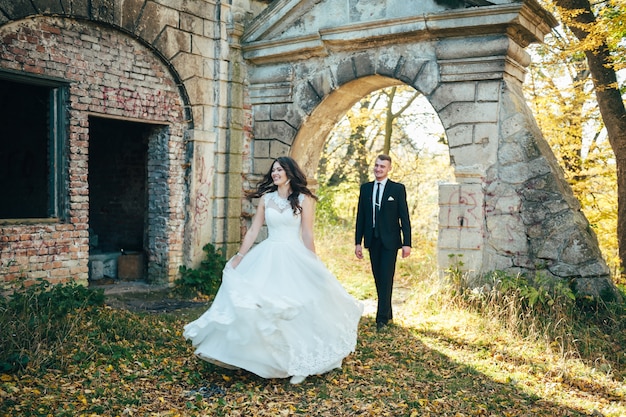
[263,191,304,241]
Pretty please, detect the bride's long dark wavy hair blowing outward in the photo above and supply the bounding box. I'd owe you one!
[248,156,317,214]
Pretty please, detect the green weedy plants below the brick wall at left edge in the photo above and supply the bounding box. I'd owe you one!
[0,280,104,372]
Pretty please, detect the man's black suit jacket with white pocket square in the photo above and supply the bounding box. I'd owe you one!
[355,179,411,249]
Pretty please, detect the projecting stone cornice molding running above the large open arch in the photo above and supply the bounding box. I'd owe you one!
[242,0,556,64]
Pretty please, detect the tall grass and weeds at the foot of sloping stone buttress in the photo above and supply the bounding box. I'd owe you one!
[436,250,626,381]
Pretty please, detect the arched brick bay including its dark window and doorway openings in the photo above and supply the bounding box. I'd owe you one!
[0,16,187,284]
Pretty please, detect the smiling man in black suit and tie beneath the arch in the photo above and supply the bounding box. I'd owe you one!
[354,155,411,330]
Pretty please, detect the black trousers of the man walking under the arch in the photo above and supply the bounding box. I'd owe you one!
[369,238,398,324]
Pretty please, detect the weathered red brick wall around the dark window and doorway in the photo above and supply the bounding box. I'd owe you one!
[0,17,186,286]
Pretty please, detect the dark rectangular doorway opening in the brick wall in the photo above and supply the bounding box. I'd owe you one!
[88,117,154,280]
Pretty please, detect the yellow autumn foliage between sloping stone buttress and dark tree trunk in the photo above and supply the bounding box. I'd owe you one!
[525,10,620,271]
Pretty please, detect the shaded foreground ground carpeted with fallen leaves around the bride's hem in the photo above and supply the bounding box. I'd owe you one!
[0,302,621,417]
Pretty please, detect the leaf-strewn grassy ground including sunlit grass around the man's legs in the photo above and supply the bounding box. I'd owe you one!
[0,223,626,417]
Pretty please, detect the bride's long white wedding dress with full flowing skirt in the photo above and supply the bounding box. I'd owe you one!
[183,192,363,378]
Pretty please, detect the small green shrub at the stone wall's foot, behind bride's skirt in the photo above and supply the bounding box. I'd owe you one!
[174,243,226,296]
